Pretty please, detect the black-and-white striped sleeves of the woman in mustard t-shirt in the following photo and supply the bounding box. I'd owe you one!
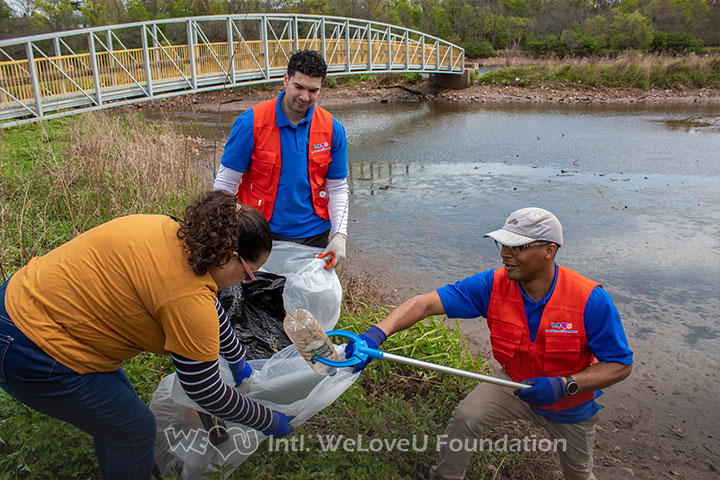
[171,299,272,430]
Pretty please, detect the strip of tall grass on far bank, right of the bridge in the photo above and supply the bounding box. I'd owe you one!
[478,56,720,88]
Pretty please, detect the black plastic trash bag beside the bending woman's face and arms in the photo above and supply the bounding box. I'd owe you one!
[218,272,292,360]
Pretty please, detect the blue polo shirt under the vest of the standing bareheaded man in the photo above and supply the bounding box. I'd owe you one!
[220,91,348,238]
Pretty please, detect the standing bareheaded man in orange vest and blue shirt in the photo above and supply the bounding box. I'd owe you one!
[214,50,349,269]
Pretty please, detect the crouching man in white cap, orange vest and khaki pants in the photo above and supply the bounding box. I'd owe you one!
[348,207,632,479]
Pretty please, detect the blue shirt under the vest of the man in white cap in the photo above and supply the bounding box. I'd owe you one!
[437,264,632,423]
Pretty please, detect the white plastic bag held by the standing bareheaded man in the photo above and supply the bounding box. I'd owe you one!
[261,242,342,330]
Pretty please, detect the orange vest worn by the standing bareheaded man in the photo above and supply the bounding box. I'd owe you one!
[237,98,333,221]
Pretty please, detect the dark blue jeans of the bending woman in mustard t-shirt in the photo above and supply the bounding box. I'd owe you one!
[0,280,155,480]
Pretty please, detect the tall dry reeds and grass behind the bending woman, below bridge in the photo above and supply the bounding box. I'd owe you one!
[0,113,208,279]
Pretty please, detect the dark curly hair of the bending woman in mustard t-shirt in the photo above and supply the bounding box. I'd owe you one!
[177,190,272,275]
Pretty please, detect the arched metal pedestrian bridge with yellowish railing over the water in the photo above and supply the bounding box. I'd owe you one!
[0,14,465,127]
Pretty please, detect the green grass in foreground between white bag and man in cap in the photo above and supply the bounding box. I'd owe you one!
[211,309,501,480]
